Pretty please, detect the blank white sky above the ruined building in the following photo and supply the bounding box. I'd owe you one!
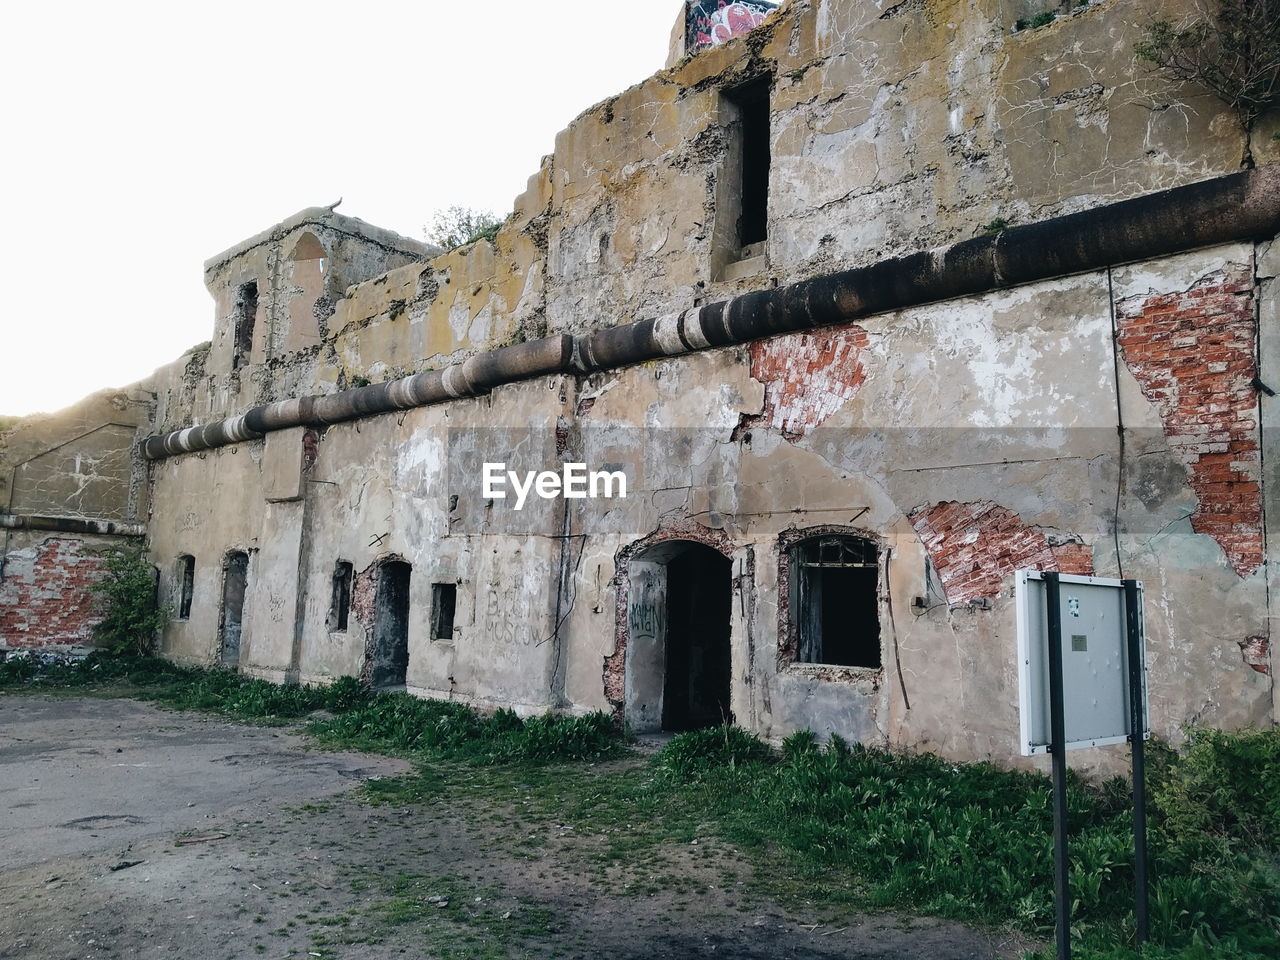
[0,0,681,415]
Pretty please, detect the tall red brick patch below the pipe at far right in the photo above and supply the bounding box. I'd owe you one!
[1116,264,1262,576]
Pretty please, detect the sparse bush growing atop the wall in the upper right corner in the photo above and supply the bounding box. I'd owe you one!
[1134,0,1280,168]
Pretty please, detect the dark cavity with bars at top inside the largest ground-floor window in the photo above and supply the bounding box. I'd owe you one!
[791,536,881,669]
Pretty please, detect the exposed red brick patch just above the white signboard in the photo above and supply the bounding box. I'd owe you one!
[908,500,1093,603]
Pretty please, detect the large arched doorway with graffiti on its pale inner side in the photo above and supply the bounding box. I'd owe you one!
[625,540,732,732]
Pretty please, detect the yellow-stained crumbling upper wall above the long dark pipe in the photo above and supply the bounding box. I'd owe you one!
[145,0,1280,429]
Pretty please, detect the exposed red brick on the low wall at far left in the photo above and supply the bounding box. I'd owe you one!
[0,538,104,649]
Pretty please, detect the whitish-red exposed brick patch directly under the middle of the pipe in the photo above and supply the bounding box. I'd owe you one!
[745,324,869,442]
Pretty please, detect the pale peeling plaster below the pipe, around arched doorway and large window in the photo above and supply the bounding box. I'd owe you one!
[552,244,1272,763]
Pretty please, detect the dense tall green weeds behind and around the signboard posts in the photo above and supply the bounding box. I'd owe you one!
[653,731,1280,960]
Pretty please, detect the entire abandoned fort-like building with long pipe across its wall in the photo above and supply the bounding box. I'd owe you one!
[0,0,1280,763]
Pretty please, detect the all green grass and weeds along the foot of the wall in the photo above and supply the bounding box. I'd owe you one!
[0,654,1280,960]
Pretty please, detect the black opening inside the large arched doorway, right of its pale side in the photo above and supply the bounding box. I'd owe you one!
[662,544,733,731]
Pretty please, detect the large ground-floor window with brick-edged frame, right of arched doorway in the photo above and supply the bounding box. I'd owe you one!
[782,531,884,671]
